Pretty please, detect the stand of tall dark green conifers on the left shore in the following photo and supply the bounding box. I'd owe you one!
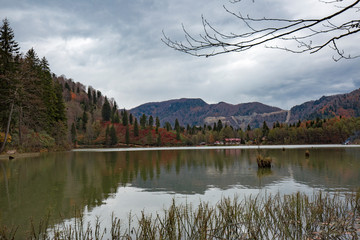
[0,19,67,152]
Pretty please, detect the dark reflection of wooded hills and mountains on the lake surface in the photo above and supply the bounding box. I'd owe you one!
[0,149,360,238]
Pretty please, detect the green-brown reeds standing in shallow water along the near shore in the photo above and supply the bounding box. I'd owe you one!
[0,191,360,240]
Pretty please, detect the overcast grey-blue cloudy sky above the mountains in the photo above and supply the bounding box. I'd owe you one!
[0,0,360,109]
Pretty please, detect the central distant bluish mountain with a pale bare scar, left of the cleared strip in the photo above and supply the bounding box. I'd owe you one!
[130,98,288,128]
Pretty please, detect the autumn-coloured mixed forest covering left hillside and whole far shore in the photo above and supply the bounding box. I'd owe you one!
[0,19,360,152]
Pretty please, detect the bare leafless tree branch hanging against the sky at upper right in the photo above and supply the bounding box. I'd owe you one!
[161,0,360,61]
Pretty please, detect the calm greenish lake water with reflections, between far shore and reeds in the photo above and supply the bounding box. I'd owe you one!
[0,147,360,236]
